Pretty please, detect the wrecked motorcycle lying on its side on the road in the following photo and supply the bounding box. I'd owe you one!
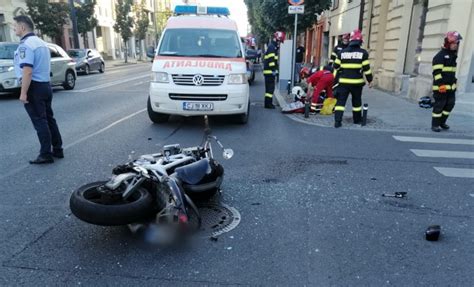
[69,116,234,240]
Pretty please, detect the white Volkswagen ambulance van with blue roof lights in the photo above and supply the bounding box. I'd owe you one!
[147,5,250,124]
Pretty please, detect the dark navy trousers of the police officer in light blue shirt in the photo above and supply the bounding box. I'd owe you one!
[25,81,63,156]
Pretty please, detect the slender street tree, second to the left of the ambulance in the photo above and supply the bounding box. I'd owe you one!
[114,0,133,63]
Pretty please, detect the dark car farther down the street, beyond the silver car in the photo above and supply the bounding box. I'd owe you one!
[67,49,105,75]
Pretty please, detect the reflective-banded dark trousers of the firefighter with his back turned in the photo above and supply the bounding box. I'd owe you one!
[334,84,364,124]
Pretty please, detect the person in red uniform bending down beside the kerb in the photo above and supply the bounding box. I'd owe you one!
[308,65,334,113]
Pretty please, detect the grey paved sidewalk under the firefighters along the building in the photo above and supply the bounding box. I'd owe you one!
[275,87,474,137]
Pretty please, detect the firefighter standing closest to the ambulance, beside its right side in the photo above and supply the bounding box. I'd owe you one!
[263,31,285,109]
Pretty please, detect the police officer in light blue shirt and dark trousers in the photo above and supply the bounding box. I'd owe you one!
[13,15,64,164]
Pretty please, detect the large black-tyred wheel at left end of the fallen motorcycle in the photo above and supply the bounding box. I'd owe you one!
[69,181,156,226]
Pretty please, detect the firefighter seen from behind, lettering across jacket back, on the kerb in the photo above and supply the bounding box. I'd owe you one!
[334,29,372,128]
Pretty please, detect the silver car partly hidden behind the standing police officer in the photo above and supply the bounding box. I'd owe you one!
[0,42,76,93]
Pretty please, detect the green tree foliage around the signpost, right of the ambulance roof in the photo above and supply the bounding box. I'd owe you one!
[244,0,331,43]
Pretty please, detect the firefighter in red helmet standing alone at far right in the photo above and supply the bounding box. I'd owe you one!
[431,31,462,132]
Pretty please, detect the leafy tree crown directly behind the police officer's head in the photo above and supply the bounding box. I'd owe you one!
[26,0,70,46]
